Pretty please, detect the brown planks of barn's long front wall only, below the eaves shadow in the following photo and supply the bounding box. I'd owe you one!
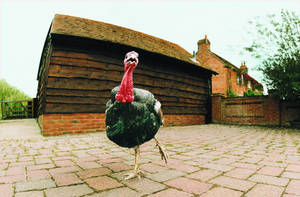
[43,47,210,115]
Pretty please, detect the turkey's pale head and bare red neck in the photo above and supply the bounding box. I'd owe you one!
[115,51,139,103]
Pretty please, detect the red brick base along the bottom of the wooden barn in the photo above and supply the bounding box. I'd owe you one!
[38,113,205,136]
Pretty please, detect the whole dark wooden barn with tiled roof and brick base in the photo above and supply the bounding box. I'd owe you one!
[37,15,216,135]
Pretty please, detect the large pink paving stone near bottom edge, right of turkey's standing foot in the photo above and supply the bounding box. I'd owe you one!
[165,177,212,194]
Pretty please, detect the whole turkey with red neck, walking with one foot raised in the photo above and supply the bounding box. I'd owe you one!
[105,51,168,180]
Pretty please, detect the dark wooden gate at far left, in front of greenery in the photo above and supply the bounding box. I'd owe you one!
[1,99,35,120]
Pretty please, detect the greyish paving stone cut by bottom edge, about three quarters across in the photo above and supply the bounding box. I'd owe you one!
[200,187,243,197]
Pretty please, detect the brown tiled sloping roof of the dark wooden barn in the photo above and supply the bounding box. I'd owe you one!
[50,14,216,74]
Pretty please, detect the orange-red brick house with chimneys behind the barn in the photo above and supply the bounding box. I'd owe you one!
[196,36,263,96]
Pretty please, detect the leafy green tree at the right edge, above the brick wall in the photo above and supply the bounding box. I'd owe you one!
[244,10,300,99]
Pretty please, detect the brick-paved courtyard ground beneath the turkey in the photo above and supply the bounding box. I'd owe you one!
[0,124,300,197]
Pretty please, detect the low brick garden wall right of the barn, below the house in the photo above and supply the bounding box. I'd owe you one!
[212,94,300,126]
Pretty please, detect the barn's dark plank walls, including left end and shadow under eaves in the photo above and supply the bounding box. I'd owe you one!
[38,35,212,115]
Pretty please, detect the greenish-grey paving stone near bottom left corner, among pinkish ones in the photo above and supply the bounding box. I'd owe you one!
[16,179,56,192]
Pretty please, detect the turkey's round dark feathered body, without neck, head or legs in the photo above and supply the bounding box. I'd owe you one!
[105,86,162,148]
